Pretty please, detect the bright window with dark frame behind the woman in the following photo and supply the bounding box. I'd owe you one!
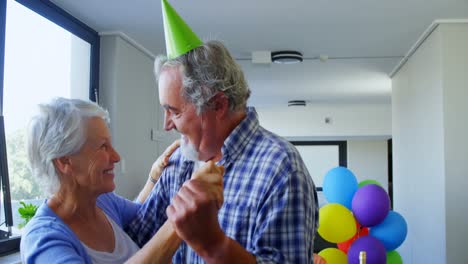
[0,0,99,254]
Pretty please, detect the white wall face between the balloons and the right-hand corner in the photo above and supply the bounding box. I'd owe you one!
[392,26,445,263]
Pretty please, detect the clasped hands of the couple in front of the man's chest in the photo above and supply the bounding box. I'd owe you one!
[166,161,225,254]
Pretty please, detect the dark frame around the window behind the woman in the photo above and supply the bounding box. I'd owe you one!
[0,0,100,256]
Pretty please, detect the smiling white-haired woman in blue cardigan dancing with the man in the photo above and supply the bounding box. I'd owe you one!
[21,98,223,264]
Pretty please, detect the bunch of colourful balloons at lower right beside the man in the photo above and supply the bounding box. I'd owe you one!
[318,167,408,264]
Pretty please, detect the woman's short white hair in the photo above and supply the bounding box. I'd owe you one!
[28,98,109,194]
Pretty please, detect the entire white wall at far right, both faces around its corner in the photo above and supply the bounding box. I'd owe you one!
[392,24,468,263]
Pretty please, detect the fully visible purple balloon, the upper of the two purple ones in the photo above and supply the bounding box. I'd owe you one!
[352,184,390,227]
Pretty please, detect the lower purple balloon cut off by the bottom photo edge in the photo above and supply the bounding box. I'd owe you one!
[348,236,387,264]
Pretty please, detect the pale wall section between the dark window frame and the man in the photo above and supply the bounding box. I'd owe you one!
[99,35,159,199]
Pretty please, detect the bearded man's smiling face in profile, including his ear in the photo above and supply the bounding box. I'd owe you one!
[159,68,216,161]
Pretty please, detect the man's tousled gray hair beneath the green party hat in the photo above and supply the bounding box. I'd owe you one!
[154,41,250,114]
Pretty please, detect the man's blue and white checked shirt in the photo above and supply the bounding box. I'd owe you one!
[127,107,318,263]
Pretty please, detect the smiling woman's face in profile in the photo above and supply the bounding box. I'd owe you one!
[70,117,120,194]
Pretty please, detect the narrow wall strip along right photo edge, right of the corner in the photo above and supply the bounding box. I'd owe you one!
[439,23,468,263]
